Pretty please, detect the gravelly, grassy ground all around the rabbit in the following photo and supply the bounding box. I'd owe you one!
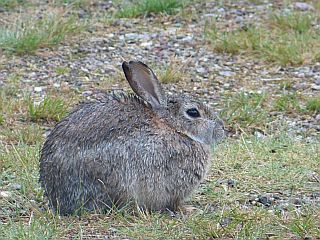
[0,0,320,239]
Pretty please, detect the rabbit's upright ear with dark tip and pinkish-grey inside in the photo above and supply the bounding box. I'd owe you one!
[122,61,167,108]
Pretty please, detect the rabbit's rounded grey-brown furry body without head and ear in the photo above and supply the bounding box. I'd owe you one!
[40,95,208,214]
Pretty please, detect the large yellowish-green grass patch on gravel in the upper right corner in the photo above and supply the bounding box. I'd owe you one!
[205,12,320,65]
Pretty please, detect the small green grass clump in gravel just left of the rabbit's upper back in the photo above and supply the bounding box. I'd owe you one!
[27,97,67,122]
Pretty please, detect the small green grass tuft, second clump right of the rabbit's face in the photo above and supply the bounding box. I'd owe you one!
[273,92,302,113]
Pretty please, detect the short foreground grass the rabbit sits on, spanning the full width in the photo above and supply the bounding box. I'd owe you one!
[0,134,320,239]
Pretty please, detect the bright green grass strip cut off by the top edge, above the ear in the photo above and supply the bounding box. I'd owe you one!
[116,0,185,18]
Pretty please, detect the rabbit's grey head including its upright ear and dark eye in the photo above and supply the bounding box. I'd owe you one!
[122,61,224,145]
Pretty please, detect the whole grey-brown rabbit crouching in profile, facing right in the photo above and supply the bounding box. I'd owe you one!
[39,61,224,215]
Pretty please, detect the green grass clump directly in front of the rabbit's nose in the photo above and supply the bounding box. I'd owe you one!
[220,92,268,129]
